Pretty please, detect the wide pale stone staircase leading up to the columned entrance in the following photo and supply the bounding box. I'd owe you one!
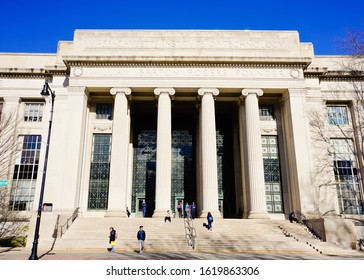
[28,214,362,254]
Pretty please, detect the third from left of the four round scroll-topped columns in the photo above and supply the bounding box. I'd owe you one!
[198,88,221,217]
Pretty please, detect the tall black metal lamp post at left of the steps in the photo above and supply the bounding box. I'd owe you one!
[29,81,56,260]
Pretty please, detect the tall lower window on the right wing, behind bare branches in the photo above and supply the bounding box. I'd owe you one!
[331,139,363,214]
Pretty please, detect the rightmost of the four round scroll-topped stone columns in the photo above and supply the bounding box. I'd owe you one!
[242,89,269,219]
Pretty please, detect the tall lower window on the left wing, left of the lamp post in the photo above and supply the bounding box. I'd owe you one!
[9,135,42,211]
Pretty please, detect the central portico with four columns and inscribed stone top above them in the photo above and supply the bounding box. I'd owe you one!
[59,31,312,218]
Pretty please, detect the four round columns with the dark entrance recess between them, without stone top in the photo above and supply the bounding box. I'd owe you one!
[81,83,288,218]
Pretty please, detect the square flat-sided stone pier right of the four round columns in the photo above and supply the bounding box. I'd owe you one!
[282,88,316,215]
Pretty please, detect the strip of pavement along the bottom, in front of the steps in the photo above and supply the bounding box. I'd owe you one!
[0,247,364,260]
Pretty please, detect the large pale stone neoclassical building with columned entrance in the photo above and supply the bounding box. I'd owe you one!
[0,30,363,247]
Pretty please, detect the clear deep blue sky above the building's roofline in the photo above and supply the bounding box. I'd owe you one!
[0,0,364,55]
